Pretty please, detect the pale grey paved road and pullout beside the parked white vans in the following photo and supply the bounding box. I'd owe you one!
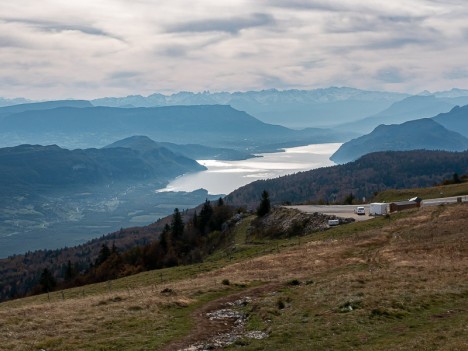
[285,195,468,221]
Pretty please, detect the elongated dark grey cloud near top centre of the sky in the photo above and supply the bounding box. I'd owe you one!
[168,13,275,34]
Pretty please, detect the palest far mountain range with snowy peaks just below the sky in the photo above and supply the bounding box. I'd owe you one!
[92,87,409,128]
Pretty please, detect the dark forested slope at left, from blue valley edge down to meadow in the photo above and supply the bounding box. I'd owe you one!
[0,199,236,301]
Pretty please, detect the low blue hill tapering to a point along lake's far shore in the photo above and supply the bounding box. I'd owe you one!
[105,136,255,161]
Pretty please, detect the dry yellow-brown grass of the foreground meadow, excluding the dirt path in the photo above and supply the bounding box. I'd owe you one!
[0,204,468,351]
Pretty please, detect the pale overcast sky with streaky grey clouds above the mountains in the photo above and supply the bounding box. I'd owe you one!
[0,0,468,99]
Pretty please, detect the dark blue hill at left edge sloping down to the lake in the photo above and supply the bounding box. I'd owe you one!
[0,145,205,196]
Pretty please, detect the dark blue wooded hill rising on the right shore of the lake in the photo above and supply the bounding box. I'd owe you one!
[330,118,468,163]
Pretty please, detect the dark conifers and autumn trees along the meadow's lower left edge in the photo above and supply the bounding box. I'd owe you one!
[1,198,242,299]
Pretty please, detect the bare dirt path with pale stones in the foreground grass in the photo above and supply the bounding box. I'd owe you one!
[161,283,283,351]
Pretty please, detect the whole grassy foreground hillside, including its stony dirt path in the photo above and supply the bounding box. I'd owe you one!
[0,204,468,351]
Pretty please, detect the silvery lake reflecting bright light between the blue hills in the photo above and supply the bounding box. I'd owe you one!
[157,143,341,194]
